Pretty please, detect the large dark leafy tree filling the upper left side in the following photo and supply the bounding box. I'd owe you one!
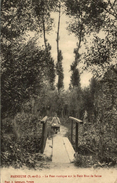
[1,0,55,117]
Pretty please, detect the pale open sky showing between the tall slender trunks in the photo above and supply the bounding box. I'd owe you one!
[47,13,92,90]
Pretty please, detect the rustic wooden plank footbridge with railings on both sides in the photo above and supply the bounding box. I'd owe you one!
[41,116,82,163]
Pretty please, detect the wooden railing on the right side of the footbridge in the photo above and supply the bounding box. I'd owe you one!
[69,116,83,152]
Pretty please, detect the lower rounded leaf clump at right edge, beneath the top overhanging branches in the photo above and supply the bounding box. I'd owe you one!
[82,33,117,78]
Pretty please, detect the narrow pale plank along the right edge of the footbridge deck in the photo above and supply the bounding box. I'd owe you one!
[63,137,75,162]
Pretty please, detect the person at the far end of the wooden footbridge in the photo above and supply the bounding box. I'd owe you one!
[51,112,61,133]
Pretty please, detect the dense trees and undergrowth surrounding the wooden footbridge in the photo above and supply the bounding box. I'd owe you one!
[1,0,117,167]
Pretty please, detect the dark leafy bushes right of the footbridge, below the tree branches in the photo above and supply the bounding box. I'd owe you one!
[75,67,117,166]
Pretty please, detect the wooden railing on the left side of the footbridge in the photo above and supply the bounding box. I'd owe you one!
[41,116,48,153]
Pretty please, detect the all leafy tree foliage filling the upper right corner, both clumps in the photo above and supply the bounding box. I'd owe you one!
[65,0,117,75]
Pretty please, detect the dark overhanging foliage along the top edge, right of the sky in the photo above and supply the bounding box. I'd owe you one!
[65,0,116,35]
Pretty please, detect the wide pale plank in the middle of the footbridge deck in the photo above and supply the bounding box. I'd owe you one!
[52,135,70,163]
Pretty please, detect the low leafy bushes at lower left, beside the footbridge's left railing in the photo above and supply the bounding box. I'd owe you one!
[1,102,44,168]
